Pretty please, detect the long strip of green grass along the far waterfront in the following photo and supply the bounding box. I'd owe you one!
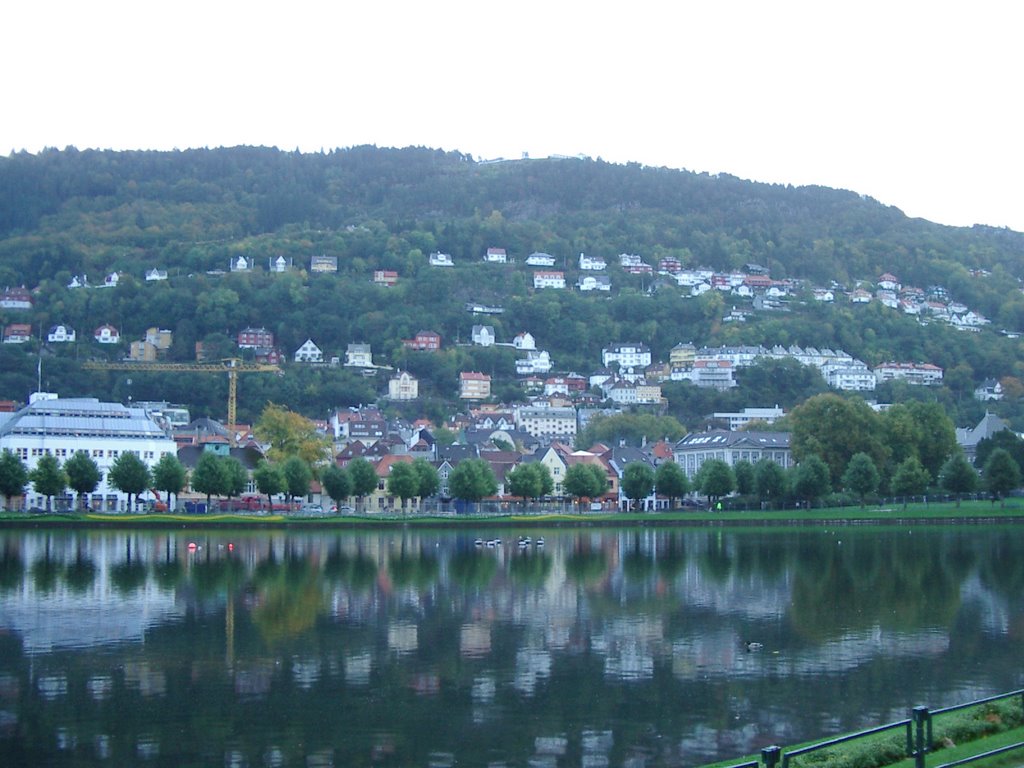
[0,499,1024,528]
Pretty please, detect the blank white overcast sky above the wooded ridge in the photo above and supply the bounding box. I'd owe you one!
[0,0,1024,231]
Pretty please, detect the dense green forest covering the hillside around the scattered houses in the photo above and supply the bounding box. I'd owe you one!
[0,146,1024,427]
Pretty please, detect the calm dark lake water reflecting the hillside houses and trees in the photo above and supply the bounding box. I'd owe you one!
[0,526,1024,768]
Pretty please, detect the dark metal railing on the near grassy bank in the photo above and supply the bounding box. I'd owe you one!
[728,688,1024,768]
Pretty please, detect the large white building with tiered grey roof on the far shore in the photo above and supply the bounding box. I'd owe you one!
[0,392,177,510]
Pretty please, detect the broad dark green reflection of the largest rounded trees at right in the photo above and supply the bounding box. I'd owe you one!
[790,531,967,639]
